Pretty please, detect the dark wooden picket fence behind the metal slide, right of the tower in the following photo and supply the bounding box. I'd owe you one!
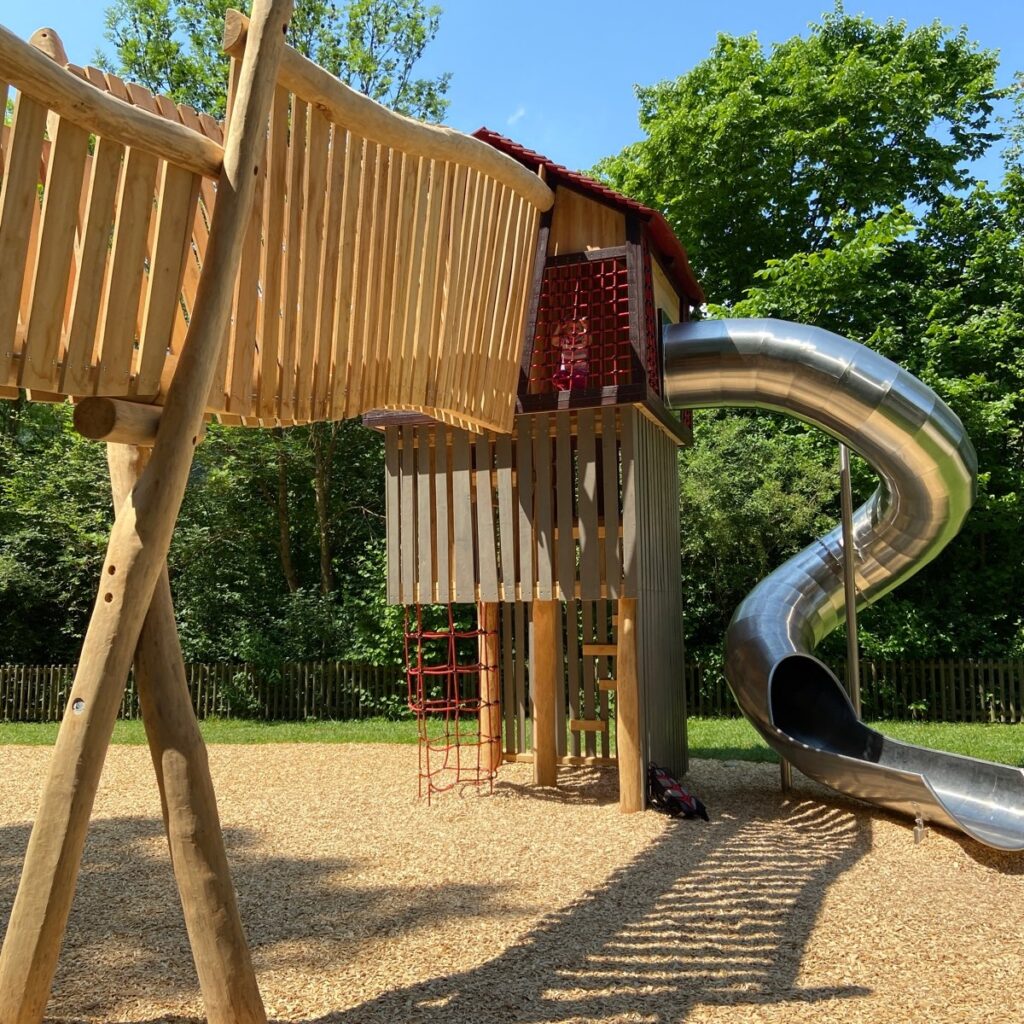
[686,657,1024,723]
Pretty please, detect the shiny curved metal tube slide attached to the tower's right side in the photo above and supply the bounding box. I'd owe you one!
[665,319,1024,850]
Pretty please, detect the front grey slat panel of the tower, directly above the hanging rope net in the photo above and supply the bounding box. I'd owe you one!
[385,407,643,604]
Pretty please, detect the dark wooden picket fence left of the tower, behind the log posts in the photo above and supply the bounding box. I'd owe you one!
[0,662,407,722]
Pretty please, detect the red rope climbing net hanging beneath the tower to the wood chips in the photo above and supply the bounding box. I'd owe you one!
[406,604,501,803]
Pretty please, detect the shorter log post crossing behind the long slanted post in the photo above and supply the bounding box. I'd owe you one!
[106,444,266,1024]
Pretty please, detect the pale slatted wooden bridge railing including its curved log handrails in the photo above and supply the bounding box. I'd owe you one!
[0,12,552,431]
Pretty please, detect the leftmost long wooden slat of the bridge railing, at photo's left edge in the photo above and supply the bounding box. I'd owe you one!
[0,92,46,384]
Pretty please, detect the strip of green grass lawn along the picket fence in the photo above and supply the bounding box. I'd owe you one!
[0,718,1024,766]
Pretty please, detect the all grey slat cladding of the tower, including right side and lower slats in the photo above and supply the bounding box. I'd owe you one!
[386,406,686,771]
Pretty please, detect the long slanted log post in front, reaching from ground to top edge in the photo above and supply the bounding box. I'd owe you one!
[0,0,292,1024]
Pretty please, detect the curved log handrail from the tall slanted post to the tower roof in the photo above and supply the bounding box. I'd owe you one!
[223,9,555,212]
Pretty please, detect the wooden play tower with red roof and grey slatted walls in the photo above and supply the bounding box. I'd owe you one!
[374,129,703,810]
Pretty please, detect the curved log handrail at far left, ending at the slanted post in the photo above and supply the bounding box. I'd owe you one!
[0,26,224,178]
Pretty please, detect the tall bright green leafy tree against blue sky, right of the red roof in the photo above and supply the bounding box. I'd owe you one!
[598,7,997,303]
